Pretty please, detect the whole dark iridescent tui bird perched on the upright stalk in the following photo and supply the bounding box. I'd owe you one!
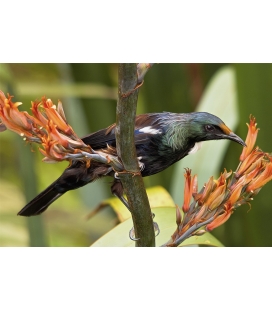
[18,112,246,216]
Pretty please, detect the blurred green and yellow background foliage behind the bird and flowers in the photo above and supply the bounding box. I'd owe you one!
[0,63,272,246]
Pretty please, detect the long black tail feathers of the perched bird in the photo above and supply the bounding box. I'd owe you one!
[17,181,65,216]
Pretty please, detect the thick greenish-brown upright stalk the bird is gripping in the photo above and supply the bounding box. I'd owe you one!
[116,64,155,247]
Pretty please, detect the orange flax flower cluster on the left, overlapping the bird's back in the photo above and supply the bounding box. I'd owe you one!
[0,90,124,171]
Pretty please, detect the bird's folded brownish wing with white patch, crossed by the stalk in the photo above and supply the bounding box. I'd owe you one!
[81,113,165,150]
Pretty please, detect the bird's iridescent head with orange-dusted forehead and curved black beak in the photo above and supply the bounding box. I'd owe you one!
[188,112,246,146]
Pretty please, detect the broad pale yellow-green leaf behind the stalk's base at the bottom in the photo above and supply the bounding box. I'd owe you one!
[91,207,223,247]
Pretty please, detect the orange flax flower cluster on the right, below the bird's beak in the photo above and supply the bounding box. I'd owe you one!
[163,116,272,247]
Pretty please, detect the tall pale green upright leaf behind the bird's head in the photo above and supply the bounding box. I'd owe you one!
[170,66,238,205]
